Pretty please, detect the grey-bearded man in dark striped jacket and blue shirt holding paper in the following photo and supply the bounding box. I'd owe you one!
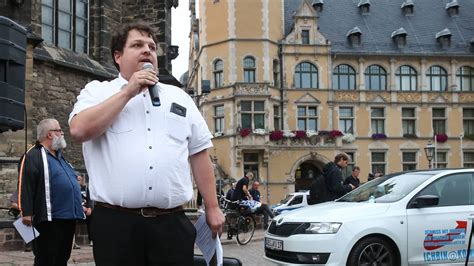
[18,119,85,266]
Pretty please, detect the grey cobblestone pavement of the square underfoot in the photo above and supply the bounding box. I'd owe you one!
[0,229,271,266]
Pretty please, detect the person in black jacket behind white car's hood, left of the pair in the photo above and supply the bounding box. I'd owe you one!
[323,153,354,201]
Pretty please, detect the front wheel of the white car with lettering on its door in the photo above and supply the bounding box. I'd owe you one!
[347,236,399,266]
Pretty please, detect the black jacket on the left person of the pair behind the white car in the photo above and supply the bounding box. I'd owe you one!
[323,162,352,201]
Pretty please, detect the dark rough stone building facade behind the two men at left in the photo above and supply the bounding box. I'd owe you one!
[0,0,179,244]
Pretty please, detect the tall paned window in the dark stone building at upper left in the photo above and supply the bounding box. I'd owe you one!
[41,0,89,53]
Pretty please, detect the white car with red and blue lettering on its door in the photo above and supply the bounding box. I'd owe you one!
[265,169,474,266]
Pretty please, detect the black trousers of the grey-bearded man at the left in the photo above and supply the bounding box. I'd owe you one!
[33,219,76,266]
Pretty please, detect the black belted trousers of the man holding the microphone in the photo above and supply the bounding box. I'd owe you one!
[91,206,196,266]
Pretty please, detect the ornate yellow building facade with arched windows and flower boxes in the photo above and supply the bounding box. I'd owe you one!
[186,0,474,206]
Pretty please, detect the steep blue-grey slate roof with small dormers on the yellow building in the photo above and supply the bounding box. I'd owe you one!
[284,0,474,56]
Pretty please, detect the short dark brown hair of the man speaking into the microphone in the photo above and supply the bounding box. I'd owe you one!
[110,21,158,71]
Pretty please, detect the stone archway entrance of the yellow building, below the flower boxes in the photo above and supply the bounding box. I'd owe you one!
[291,152,329,191]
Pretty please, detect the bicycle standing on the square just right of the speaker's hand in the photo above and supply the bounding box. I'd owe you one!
[219,196,256,245]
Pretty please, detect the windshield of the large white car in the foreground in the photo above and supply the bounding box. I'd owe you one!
[337,172,436,202]
